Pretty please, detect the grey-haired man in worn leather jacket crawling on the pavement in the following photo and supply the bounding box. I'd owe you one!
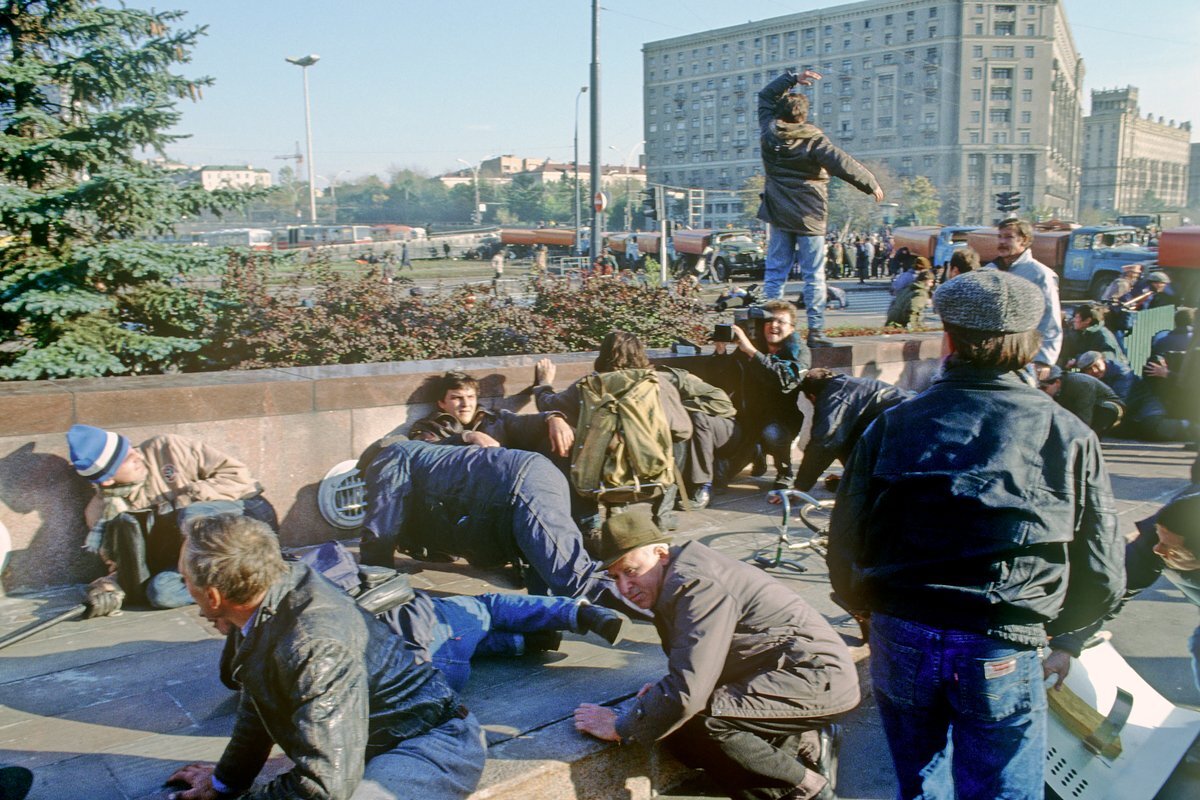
[168,515,485,800]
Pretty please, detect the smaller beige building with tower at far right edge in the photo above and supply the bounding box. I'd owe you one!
[1080,86,1192,216]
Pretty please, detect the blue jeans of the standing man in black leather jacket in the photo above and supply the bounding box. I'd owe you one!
[871,614,1046,800]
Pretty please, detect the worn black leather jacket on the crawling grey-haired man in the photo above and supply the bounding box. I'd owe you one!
[215,564,461,800]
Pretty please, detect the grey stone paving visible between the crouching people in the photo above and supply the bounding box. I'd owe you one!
[0,441,1200,800]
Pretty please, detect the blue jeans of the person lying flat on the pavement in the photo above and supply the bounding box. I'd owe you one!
[422,594,578,692]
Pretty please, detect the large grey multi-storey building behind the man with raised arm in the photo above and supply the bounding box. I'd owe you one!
[642,0,1084,225]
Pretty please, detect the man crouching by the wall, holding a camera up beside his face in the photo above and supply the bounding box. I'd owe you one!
[713,300,812,489]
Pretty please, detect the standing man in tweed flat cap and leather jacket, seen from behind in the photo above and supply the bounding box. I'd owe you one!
[828,270,1124,800]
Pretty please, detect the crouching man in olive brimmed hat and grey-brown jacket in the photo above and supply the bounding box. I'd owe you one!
[575,509,859,800]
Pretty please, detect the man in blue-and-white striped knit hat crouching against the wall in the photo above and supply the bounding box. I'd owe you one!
[67,425,278,615]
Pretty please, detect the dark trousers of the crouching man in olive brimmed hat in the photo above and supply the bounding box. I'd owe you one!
[664,714,828,800]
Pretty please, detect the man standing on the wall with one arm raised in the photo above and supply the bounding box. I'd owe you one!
[758,70,883,347]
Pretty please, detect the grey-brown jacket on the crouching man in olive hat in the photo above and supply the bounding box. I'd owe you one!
[617,542,859,742]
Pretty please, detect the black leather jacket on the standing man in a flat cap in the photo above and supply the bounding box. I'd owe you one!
[828,357,1124,646]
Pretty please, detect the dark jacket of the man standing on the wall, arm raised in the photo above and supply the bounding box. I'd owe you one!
[758,72,880,236]
